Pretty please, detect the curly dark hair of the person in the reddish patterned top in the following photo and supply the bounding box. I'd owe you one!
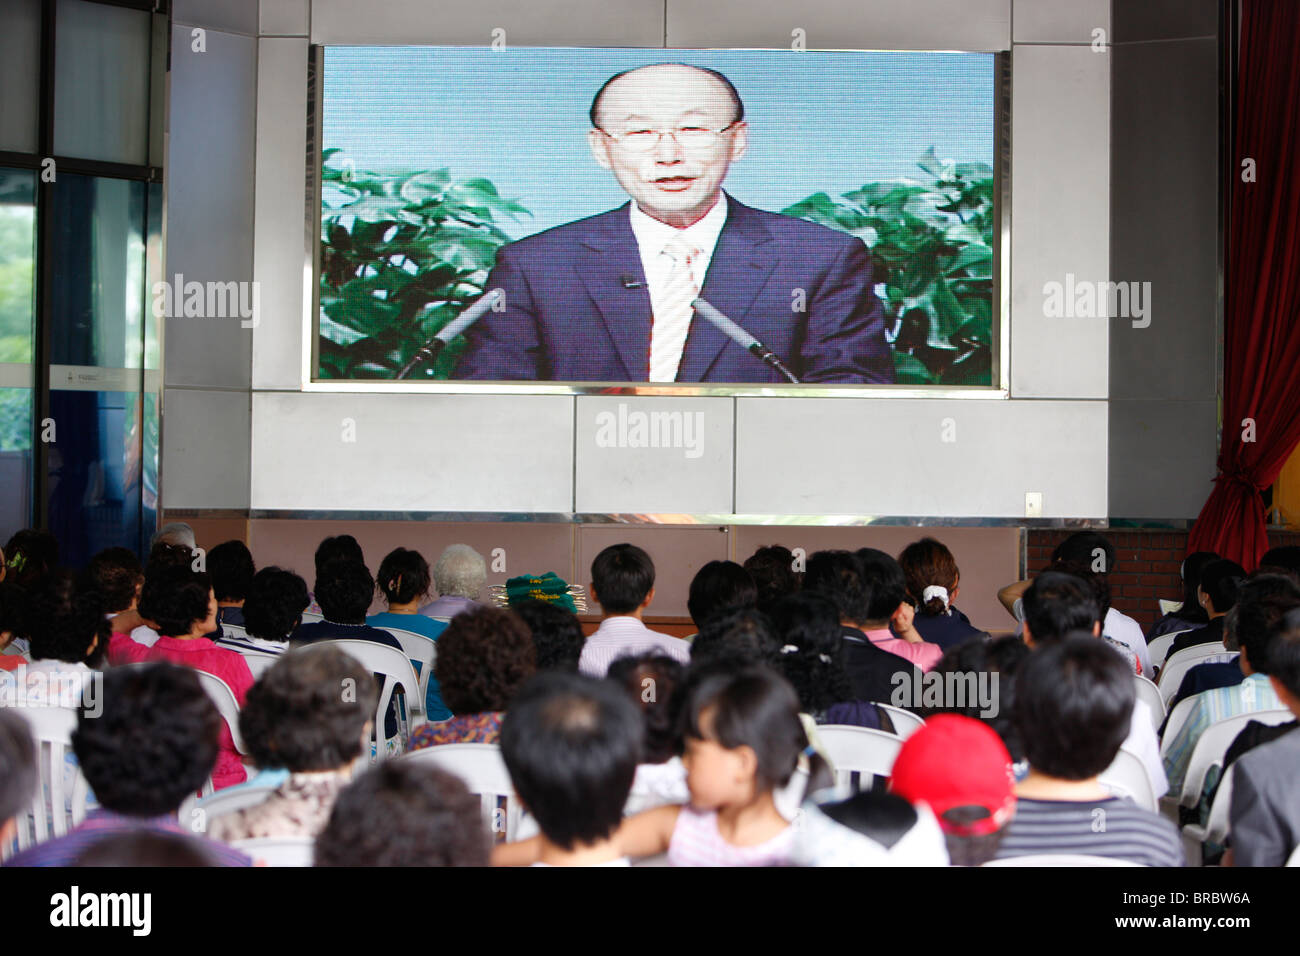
[433,607,537,714]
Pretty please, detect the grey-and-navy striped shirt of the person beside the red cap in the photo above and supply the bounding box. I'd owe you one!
[997,797,1183,866]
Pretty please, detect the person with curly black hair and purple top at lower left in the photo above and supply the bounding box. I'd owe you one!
[5,662,251,866]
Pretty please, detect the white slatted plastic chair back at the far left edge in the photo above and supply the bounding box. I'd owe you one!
[3,708,90,856]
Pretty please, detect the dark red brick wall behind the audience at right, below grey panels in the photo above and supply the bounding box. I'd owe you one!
[1026,528,1300,631]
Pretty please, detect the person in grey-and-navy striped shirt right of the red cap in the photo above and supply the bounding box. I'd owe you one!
[997,632,1183,866]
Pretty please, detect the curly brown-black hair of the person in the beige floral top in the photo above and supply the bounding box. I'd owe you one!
[239,644,380,774]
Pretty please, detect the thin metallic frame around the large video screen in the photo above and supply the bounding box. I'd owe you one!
[300,43,1011,401]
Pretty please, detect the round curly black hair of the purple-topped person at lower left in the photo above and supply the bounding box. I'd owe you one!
[73,662,221,818]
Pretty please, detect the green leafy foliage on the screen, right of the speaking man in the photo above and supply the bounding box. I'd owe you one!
[781,147,993,385]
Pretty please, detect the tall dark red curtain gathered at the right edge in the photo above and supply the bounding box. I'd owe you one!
[1188,0,1300,570]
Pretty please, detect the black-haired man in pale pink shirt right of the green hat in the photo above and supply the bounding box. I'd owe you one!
[577,544,690,678]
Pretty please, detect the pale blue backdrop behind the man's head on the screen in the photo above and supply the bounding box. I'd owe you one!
[322,47,995,238]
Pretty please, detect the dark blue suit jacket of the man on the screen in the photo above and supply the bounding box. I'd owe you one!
[455,196,894,384]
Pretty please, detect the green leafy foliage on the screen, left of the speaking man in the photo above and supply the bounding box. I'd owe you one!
[320,150,532,378]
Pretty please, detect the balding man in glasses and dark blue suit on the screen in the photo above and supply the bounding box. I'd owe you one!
[455,64,894,384]
